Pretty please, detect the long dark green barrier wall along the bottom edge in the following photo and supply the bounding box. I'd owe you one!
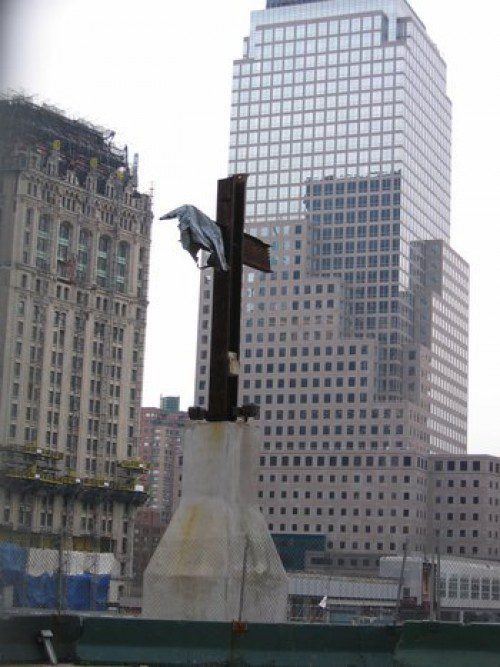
[0,615,500,667]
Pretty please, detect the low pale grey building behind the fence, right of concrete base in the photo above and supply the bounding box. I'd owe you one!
[289,556,500,625]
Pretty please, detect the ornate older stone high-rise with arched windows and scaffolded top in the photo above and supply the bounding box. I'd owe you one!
[0,98,152,574]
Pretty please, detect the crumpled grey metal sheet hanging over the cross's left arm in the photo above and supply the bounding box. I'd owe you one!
[160,204,229,271]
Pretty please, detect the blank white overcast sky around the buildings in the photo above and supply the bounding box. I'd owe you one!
[0,0,500,454]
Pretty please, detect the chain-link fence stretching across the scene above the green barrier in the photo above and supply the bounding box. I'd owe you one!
[4,522,500,625]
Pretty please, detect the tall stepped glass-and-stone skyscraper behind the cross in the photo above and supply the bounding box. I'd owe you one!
[196,0,468,565]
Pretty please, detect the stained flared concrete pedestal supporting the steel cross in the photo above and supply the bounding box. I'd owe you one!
[142,422,288,623]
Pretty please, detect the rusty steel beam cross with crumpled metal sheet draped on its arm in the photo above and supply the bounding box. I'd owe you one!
[161,174,271,421]
